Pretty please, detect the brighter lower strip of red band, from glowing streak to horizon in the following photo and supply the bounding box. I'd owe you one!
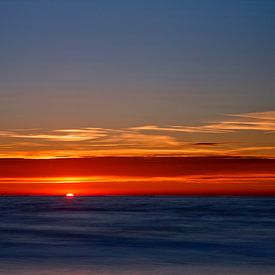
[0,174,275,198]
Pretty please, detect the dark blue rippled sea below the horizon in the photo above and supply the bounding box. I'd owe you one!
[0,197,275,274]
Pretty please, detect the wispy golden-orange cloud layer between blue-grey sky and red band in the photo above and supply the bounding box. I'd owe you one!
[0,111,275,158]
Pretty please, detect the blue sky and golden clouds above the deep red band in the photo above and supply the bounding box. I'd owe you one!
[0,0,275,193]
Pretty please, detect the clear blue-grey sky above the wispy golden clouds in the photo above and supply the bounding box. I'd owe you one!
[0,0,275,128]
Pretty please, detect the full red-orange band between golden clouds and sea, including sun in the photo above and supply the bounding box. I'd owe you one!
[0,157,275,197]
